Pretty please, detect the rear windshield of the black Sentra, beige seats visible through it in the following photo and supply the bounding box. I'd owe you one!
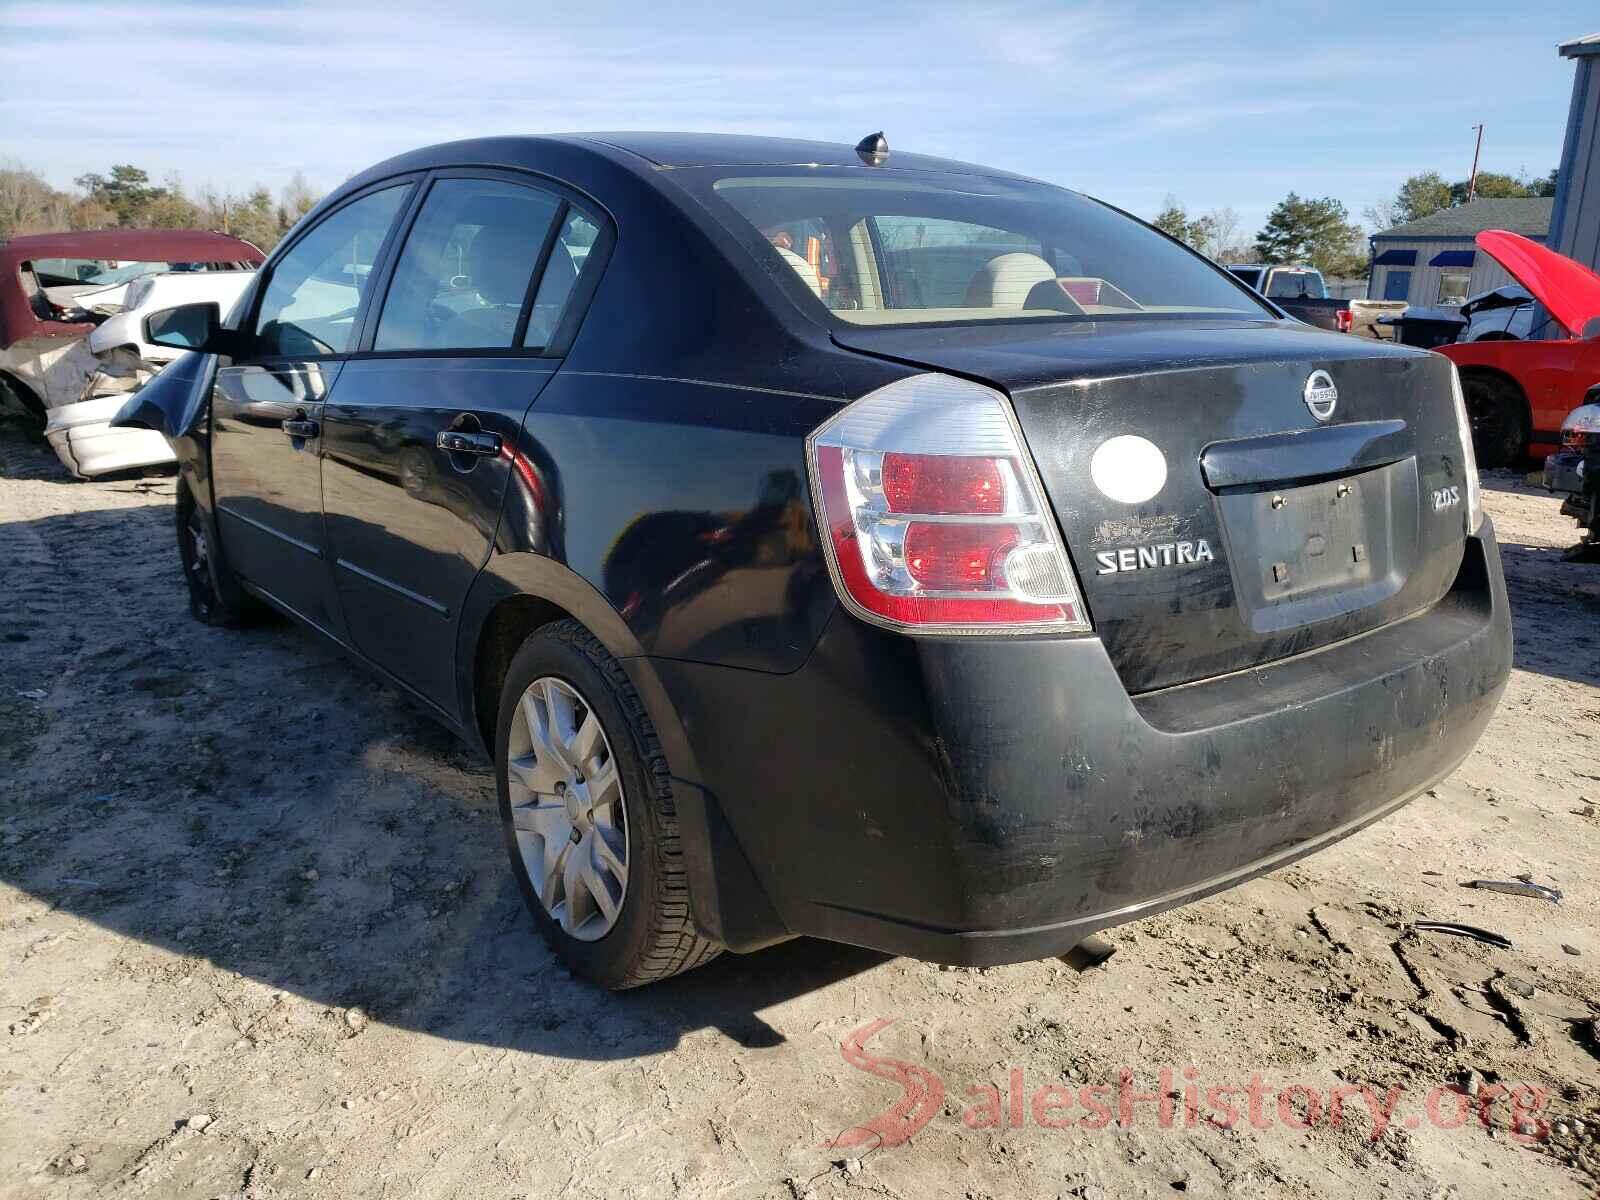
[674,166,1267,325]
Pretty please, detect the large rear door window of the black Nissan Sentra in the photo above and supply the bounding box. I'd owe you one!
[373,179,565,350]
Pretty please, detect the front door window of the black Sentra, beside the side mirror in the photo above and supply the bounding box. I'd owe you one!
[256,184,411,358]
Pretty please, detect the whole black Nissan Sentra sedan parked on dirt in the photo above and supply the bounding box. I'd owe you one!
[122,134,1510,987]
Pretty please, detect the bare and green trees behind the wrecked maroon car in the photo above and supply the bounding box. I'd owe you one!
[0,163,320,251]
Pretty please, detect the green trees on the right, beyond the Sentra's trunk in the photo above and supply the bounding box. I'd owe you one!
[1150,171,1557,278]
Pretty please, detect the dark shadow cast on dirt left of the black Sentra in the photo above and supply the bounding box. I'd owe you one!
[0,482,886,1059]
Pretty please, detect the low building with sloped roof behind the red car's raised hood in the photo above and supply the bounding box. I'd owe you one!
[1366,198,1548,309]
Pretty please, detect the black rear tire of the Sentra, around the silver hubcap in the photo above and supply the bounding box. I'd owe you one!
[494,621,722,990]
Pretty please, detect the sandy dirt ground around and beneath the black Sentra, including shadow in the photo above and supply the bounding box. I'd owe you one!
[0,429,1600,1200]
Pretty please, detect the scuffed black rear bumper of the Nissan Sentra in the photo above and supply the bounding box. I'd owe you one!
[651,525,1512,965]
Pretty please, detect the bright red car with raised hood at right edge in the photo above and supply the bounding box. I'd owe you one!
[1438,229,1600,467]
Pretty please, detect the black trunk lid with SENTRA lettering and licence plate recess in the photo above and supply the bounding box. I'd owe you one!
[834,320,1466,693]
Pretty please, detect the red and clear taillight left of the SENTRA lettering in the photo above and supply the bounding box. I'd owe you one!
[806,374,1090,634]
